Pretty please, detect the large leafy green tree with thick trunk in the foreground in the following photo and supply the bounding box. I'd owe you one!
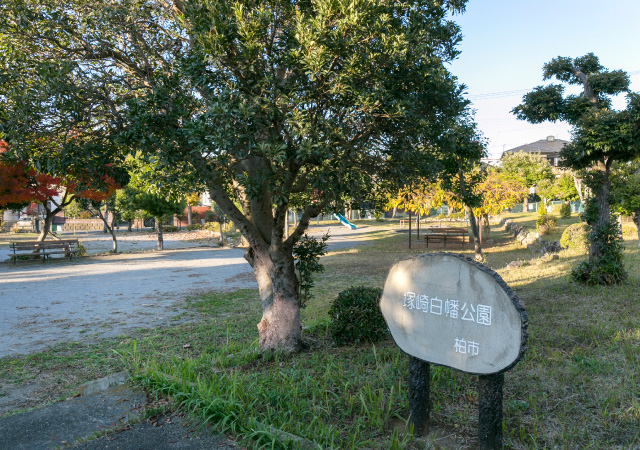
[0,0,466,351]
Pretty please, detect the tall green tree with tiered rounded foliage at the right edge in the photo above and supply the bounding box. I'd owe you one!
[512,53,640,284]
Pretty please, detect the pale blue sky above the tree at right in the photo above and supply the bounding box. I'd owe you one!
[450,0,640,158]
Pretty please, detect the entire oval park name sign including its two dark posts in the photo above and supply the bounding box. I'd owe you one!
[380,253,527,449]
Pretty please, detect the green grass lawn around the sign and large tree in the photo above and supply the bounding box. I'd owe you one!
[0,214,640,449]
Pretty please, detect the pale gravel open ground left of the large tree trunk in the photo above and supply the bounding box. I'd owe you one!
[0,226,378,358]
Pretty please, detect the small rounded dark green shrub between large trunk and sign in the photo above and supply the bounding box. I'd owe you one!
[329,286,388,345]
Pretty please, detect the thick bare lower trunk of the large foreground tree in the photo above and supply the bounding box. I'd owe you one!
[245,247,302,352]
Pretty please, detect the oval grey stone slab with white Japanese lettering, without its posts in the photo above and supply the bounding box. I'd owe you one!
[380,253,526,375]
